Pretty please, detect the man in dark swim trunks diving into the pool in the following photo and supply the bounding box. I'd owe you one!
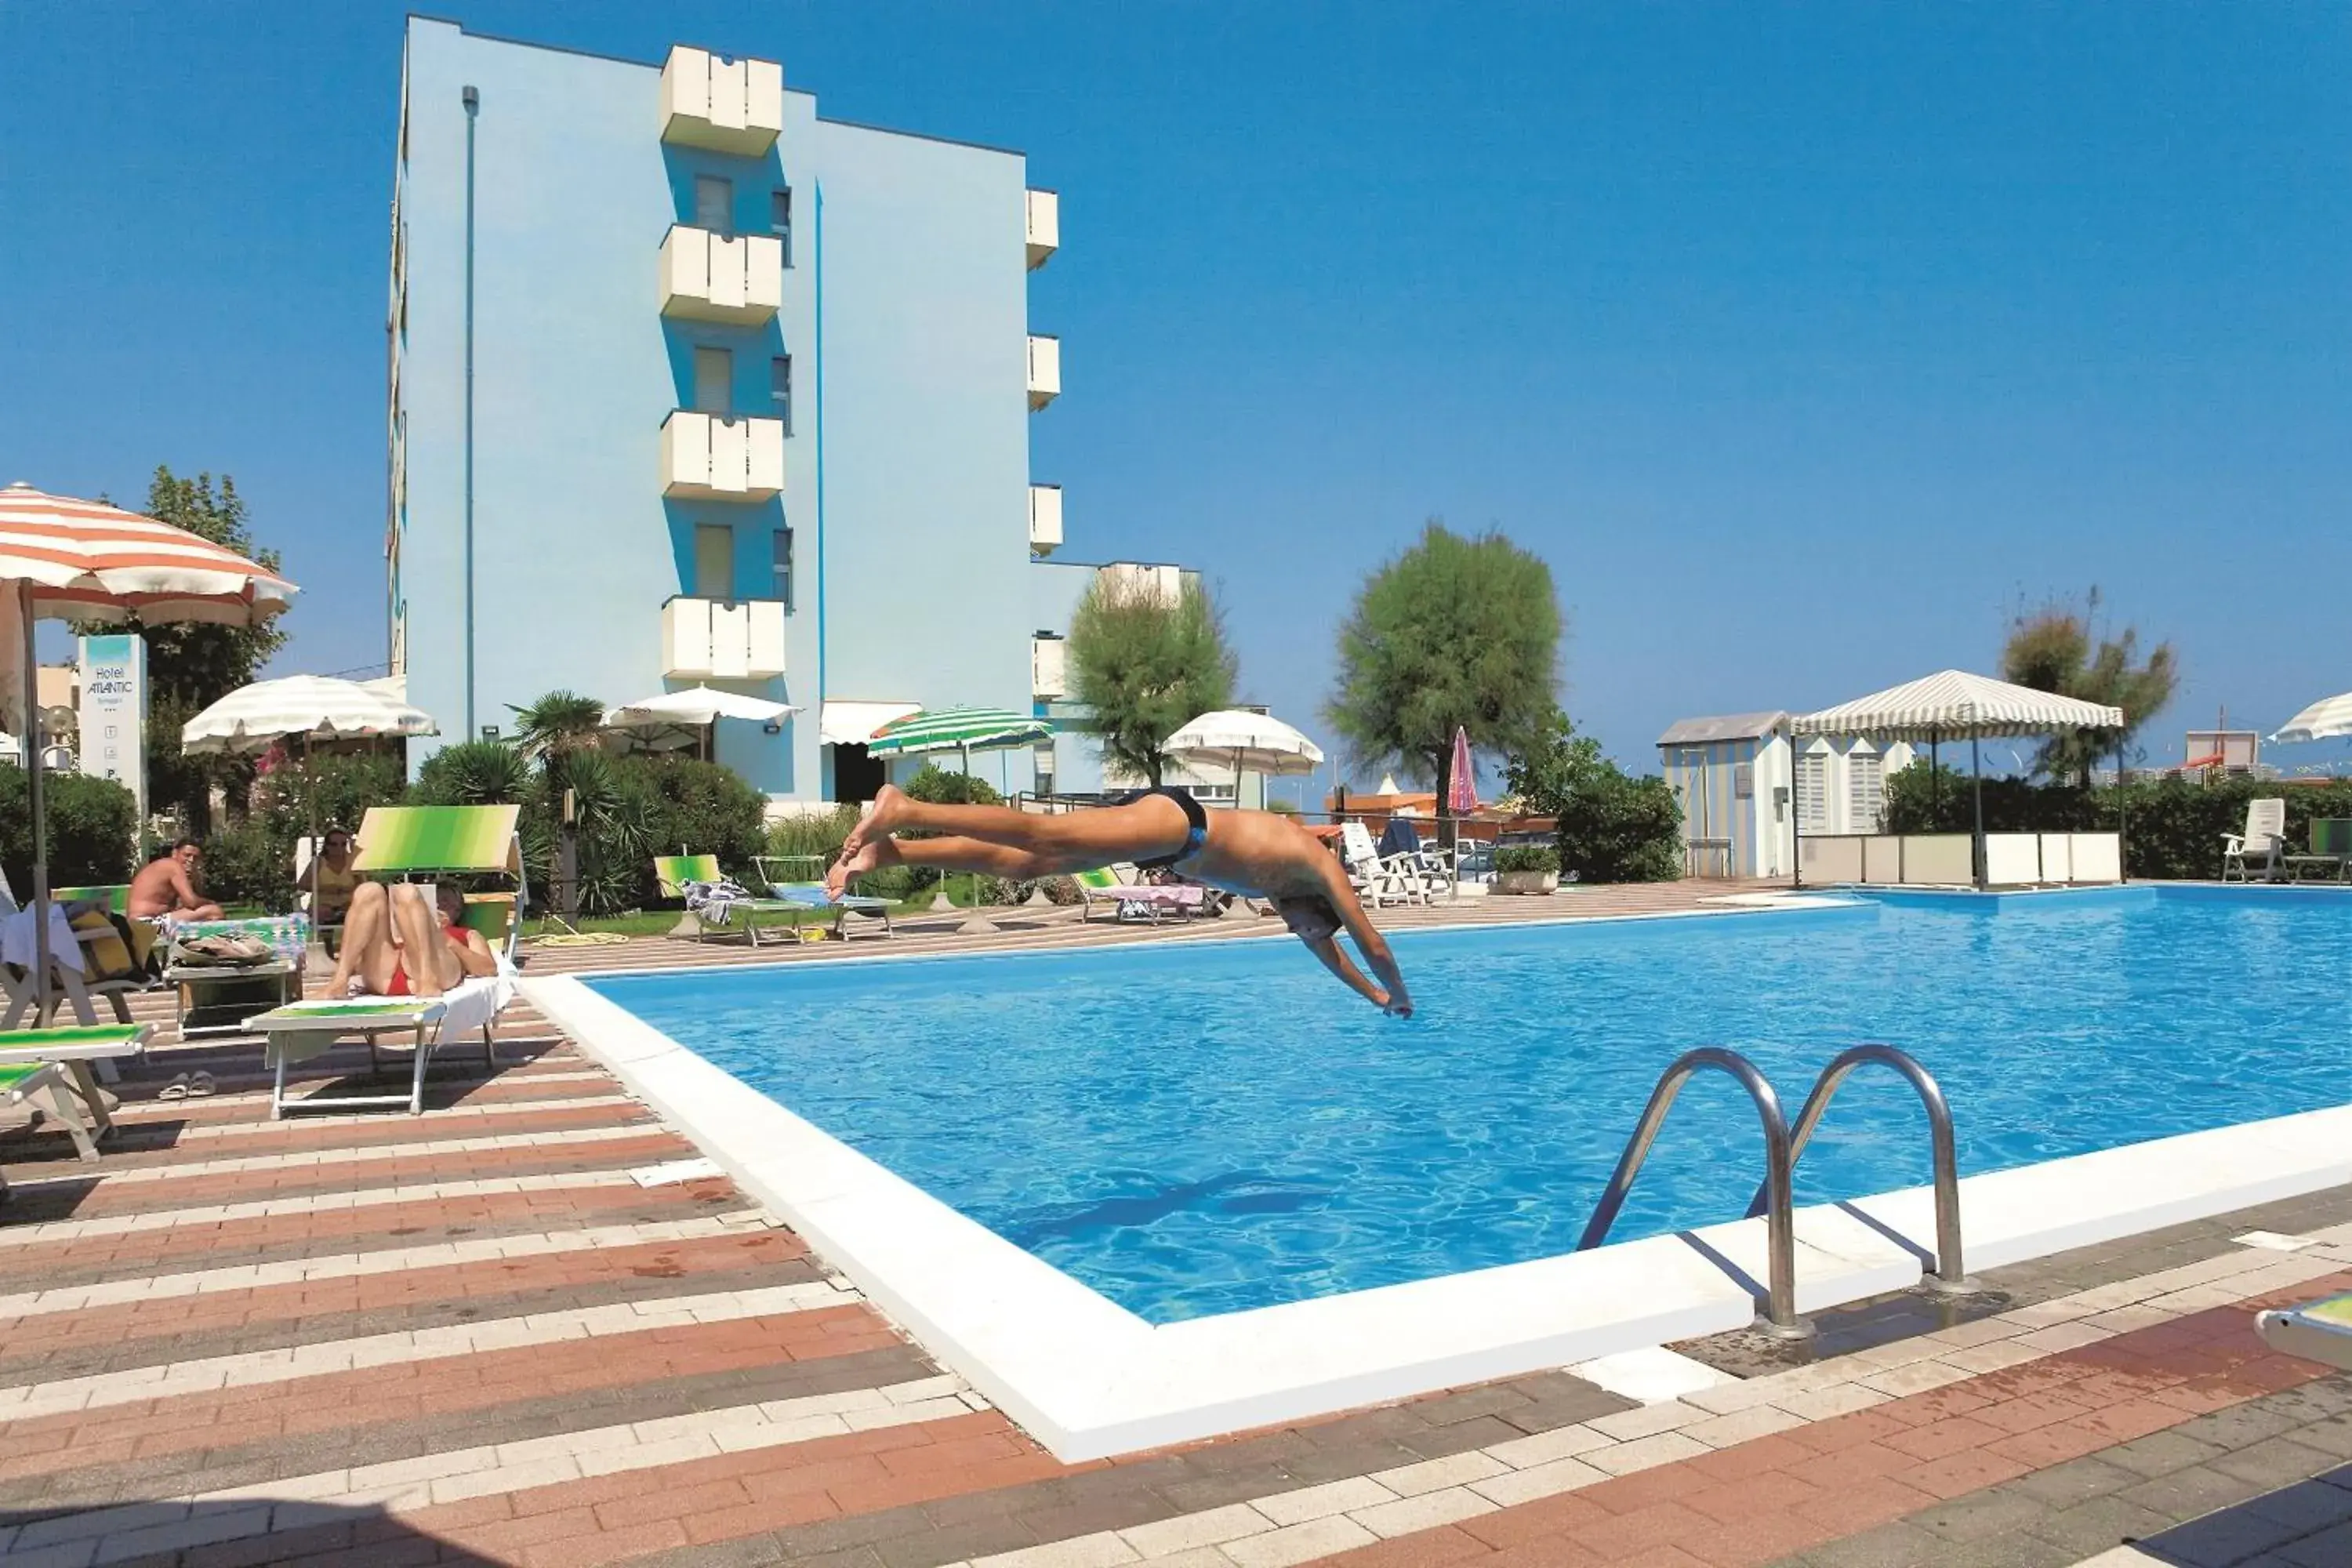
[826,785,1414,1018]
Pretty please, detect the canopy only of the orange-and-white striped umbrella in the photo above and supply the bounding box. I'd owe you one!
[0,485,294,626]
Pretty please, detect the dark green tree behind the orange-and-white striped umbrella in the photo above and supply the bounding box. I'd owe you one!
[89,466,287,834]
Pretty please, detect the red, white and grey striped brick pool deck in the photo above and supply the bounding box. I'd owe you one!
[0,884,2352,1568]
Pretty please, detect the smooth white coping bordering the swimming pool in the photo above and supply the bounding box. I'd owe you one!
[524,900,2352,1462]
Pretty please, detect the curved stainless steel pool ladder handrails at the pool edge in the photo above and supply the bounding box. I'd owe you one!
[1576,1044,1973,1340]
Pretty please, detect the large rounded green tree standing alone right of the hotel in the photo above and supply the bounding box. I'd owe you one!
[1324,517,1562,822]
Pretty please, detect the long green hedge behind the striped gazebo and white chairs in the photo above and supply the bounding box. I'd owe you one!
[1886,764,2352,881]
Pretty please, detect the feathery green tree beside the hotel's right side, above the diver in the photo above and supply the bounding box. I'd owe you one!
[1068,572,1240,785]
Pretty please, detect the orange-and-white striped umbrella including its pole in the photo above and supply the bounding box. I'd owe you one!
[0,485,294,1020]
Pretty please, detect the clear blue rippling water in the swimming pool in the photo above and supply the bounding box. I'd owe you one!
[593,888,2352,1321]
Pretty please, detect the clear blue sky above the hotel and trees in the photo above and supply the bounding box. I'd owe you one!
[0,0,2352,767]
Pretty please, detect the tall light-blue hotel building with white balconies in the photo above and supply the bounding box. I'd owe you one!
[386,16,1181,804]
